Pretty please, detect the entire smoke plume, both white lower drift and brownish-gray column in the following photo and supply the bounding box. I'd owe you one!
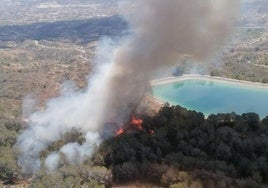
[17,0,238,173]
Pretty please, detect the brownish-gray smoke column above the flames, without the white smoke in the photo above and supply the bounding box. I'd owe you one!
[103,0,238,122]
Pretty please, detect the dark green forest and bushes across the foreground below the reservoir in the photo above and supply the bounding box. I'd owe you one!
[0,104,268,188]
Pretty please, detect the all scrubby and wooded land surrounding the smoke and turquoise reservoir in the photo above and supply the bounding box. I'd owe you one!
[0,0,268,188]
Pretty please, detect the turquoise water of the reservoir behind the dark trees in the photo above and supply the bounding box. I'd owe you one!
[152,79,268,118]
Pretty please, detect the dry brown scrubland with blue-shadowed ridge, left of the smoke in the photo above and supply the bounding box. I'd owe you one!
[0,16,126,122]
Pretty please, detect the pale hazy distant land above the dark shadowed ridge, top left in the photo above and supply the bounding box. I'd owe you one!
[0,0,117,25]
